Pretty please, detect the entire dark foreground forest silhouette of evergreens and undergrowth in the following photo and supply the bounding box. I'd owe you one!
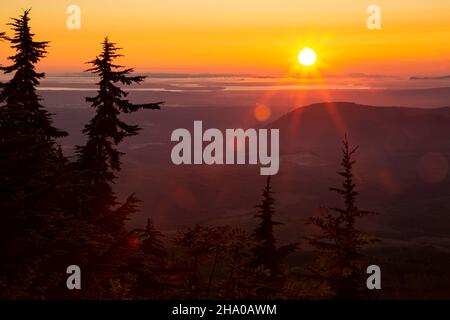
[0,10,372,299]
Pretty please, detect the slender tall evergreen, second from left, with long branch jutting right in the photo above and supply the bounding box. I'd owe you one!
[75,38,162,297]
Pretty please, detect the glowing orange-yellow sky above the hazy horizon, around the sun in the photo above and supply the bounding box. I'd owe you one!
[0,0,450,75]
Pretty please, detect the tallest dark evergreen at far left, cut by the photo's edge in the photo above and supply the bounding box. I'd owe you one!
[0,10,66,298]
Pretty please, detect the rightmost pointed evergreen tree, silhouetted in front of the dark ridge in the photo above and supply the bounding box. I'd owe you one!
[307,136,376,299]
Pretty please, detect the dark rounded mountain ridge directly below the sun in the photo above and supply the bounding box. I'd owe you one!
[269,102,450,157]
